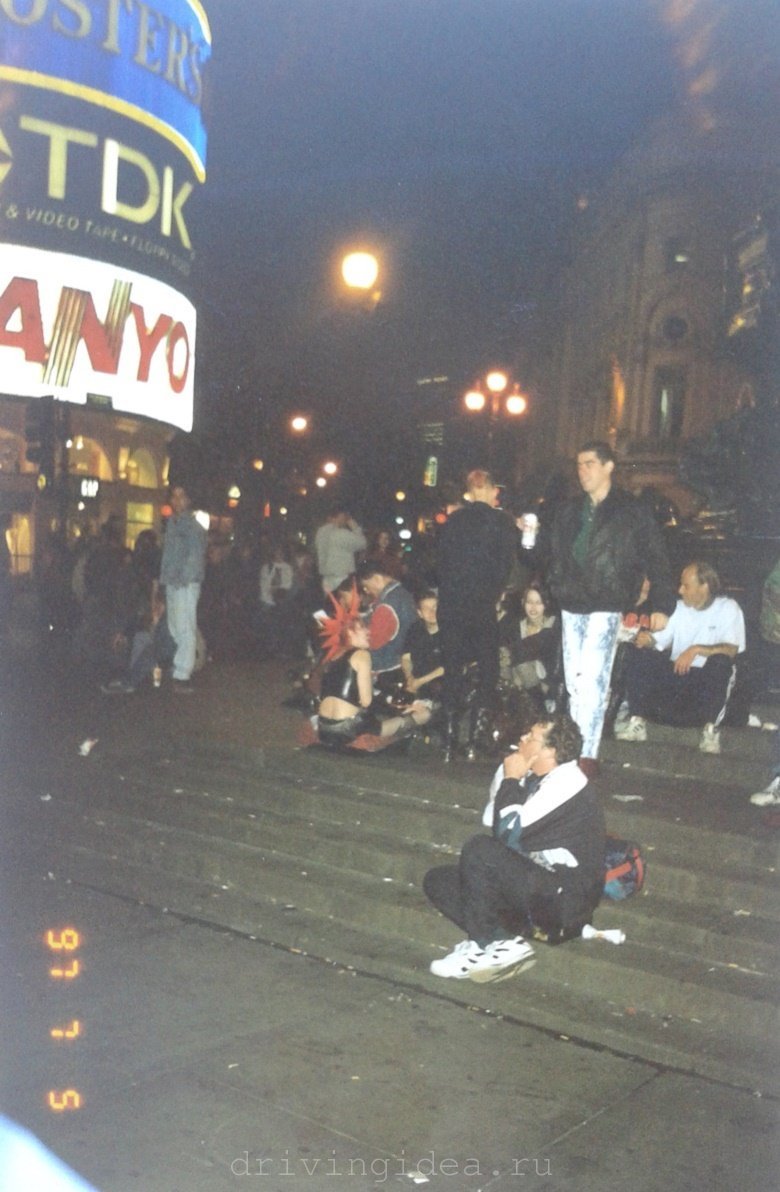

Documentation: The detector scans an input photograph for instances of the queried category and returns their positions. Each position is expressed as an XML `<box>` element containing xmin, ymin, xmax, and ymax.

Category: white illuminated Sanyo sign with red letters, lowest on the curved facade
<box><xmin>0</xmin><ymin>244</ymin><xmax>196</xmax><ymax>430</ymax></box>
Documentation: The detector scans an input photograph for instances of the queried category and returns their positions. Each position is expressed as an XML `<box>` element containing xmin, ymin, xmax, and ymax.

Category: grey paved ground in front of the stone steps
<box><xmin>0</xmin><ymin>658</ymin><xmax>780</xmax><ymax>1192</ymax></box>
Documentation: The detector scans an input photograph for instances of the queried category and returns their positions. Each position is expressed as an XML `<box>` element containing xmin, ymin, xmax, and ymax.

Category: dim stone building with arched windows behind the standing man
<box><xmin>547</xmin><ymin>117</ymin><xmax>780</xmax><ymax>514</ymax></box>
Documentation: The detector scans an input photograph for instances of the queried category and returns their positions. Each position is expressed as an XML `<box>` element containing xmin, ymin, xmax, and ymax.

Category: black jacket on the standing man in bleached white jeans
<box><xmin>547</xmin><ymin>485</ymin><xmax>676</xmax><ymax>615</ymax></box>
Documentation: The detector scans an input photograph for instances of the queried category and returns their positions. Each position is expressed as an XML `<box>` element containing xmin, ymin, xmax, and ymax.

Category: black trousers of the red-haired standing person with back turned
<box><xmin>439</xmin><ymin>607</ymin><xmax>499</xmax><ymax>713</ymax></box>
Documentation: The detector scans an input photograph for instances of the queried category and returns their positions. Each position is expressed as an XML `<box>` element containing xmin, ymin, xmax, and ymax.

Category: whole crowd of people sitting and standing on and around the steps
<box><xmin>15</xmin><ymin>441</ymin><xmax>780</xmax><ymax>981</ymax></box>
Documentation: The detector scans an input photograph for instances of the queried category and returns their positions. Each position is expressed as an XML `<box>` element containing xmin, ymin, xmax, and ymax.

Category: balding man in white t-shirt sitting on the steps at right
<box><xmin>615</xmin><ymin>563</ymin><xmax>745</xmax><ymax>753</ymax></box>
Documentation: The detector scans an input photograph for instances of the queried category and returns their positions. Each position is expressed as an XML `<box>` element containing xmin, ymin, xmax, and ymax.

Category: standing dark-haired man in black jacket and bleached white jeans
<box><xmin>547</xmin><ymin>440</ymin><xmax>676</xmax><ymax>777</ymax></box>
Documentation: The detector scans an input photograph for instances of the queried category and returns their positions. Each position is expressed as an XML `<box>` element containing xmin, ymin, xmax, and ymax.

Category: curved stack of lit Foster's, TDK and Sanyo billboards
<box><xmin>0</xmin><ymin>0</ymin><xmax>211</xmax><ymax>429</ymax></box>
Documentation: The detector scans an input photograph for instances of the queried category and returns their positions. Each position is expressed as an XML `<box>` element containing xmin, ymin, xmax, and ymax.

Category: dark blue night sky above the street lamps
<box><xmin>190</xmin><ymin>0</ymin><xmax>780</xmax><ymax>507</ymax></box>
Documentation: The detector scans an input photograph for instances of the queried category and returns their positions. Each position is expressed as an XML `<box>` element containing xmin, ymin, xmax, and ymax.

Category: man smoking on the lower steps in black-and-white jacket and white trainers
<box><xmin>423</xmin><ymin>715</ymin><xmax>605</xmax><ymax>981</ymax></box>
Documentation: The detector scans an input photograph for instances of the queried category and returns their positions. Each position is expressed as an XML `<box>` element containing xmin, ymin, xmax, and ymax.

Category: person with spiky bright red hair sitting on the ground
<box><xmin>317</xmin><ymin>589</ymin><xmax>431</xmax><ymax>749</ymax></box>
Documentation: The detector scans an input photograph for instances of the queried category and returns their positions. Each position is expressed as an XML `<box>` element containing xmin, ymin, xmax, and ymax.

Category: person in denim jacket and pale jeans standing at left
<box><xmin>160</xmin><ymin>484</ymin><xmax>208</xmax><ymax>694</ymax></box>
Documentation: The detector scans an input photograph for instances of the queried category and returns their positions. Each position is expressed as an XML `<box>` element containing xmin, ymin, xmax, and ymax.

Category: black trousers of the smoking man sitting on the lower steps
<box><xmin>422</xmin><ymin>834</ymin><xmax>563</xmax><ymax>946</ymax></box>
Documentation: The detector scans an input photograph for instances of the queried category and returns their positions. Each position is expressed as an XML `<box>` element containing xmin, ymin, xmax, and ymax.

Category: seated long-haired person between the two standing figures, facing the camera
<box><xmin>499</xmin><ymin>584</ymin><xmax>561</xmax><ymax>710</ymax></box>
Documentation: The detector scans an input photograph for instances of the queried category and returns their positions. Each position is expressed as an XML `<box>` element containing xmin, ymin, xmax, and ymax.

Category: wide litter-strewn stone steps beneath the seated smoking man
<box><xmin>6</xmin><ymin>719</ymin><xmax>780</xmax><ymax>1091</ymax></box>
